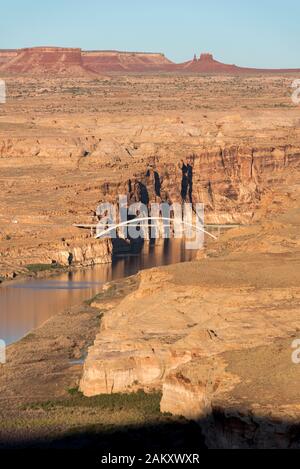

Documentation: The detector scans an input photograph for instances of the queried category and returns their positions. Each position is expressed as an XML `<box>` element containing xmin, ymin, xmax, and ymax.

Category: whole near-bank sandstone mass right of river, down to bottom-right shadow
<box><xmin>81</xmin><ymin>179</ymin><xmax>300</xmax><ymax>448</ymax></box>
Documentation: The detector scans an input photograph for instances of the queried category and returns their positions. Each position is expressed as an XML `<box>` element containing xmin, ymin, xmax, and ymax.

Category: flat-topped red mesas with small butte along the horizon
<box><xmin>0</xmin><ymin>47</ymin><xmax>300</xmax><ymax>77</ymax></box>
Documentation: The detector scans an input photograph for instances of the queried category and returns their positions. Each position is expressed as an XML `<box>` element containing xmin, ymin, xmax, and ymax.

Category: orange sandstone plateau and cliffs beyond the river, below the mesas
<box><xmin>0</xmin><ymin>76</ymin><xmax>300</xmax><ymax>276</ymax></box>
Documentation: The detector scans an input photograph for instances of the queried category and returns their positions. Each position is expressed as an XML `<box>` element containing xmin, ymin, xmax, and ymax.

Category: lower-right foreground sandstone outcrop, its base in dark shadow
<box><xmin>161</xmin><ymin>337</ymin><xmax>300</xmax><ymax>449</ymax></box>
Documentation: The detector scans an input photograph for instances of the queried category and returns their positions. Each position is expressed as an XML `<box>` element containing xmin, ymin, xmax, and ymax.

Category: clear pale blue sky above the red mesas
<box><xmin>0</xmin><ymin>0</ymin><xmax>300</xmax><ymax>67</ymax></box>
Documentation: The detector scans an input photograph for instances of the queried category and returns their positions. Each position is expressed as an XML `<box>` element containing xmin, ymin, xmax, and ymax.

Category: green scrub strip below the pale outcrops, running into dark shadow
<box><xmin>17</xmin><ymin>389</ymin><xmax>205</xmax><ymax>452</ymax></box>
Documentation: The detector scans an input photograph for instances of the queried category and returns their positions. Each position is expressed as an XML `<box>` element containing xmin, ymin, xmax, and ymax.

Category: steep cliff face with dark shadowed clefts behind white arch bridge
<box><xmin>96</xmin><ymin>145</ymin><xmax>300</xmax><ymax>224</ymax></box>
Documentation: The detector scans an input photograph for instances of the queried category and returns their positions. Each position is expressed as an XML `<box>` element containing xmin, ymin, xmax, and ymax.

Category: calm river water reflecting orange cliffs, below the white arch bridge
<box><xmin>0</xmin><ymin>240</ymin><xmax>196</xmax><ymax>344</ymax></box>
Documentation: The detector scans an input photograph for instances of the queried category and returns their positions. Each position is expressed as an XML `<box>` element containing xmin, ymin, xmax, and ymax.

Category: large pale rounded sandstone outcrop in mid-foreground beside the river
<box><xmin>81</xmin><ymin>254</ymin><xmax>300</xmax><ymax>396</ymax></box>
